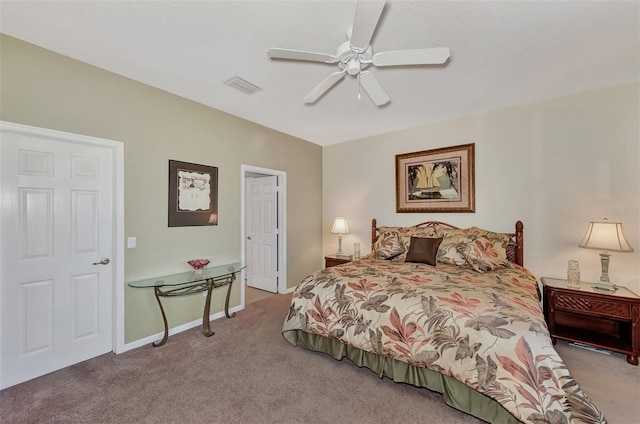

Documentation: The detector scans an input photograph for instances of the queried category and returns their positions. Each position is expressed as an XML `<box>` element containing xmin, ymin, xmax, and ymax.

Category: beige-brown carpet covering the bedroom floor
<box><xmin>0</xmin><ymin>295</ymin><xmax>640</xmax><ymax>424</ymax></box>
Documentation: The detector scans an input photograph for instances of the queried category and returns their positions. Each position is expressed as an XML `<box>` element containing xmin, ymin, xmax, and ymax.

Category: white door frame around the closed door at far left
<box><xmin>0</xmin><ymin>121</ymin><xmax>126</xmax><ymax>353</ymax></box>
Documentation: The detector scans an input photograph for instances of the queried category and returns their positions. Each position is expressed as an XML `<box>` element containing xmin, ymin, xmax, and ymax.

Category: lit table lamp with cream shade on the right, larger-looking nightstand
<box><xmin>578</xmin><ymin>218</ymin><xmax>633</xmax><ymax>292</ymax></box>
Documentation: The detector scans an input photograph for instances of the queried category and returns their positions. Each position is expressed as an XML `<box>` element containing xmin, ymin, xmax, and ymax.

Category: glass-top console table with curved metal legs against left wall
<box><xmin>129</xmin><ymin>262</ymin><xmax>245</xmax><ymax>347</ymax></box>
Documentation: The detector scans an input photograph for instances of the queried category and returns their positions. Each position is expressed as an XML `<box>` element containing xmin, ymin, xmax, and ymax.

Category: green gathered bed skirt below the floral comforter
<box><xmin>284</xmin><ymin>330</ymin><xmax>520</xmax><ymax>424</ymax></box>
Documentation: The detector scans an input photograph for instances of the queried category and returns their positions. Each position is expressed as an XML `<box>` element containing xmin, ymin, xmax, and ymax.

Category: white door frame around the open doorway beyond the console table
<box><xmin>240</xmin><ymin>164</ymin><xmax>287</xmax><ymax>308</ymax></box>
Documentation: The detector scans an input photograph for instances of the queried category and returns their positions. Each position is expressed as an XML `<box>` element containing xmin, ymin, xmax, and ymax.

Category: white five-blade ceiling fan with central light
<box><xmin>267</xmin><ymin>0</ymin><xmax>450</xmax><ymax>106</ymax></box>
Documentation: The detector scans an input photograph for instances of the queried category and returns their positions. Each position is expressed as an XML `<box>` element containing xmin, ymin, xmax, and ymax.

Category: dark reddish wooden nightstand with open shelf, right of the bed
<box><xmin>541</xmin><ymin>277</ymin><xmax>640</xmax><ymax>365</ymax></box>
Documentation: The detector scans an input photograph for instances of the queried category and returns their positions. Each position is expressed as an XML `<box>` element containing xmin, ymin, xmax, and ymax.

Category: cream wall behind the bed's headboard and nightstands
<box><xmin>323</xmin><ymin>82</ymin><xmax>640</xmax><ymax>294</ymax></box>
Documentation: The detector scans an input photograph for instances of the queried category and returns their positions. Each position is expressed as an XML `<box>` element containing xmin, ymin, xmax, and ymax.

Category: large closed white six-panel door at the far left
<box><xmin>0</xmin><ymin>130</ymin><xmax>115</xmax><ymax>388</ymax></box>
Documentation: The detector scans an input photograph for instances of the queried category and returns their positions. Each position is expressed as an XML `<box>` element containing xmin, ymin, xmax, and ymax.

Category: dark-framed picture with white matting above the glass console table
<box><xmin>169</xmin><ymin>160</ymin><xmax>218</xmax><ymax>227</ymax></box>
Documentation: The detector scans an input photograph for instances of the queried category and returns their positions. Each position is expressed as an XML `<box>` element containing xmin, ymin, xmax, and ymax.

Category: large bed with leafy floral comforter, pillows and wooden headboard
<box><xmin>282</xmin><ymin>219</ymin><xmax>606</xmax><ymax>424</ymax></box>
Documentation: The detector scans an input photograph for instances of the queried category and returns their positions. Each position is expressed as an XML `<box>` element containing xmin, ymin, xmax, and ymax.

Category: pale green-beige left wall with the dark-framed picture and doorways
<box><xmin>0</xmin><ymin>35</ymin><xmax>322</xmax><ymax>342</ymax></box>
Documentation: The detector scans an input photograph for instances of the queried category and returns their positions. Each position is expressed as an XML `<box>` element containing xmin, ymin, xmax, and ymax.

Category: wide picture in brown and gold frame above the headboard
<box><xmin>396</xmin><ymin>144</ymin><xmax>475</xmax><ymax>212</ymax></box>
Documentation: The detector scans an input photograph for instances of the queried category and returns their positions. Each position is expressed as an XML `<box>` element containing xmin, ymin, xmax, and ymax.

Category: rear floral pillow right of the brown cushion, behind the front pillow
<box><xmin>437</xmin><ymin>227</ymin><xmax>510</xmax><ymax>265</ymax></box>
